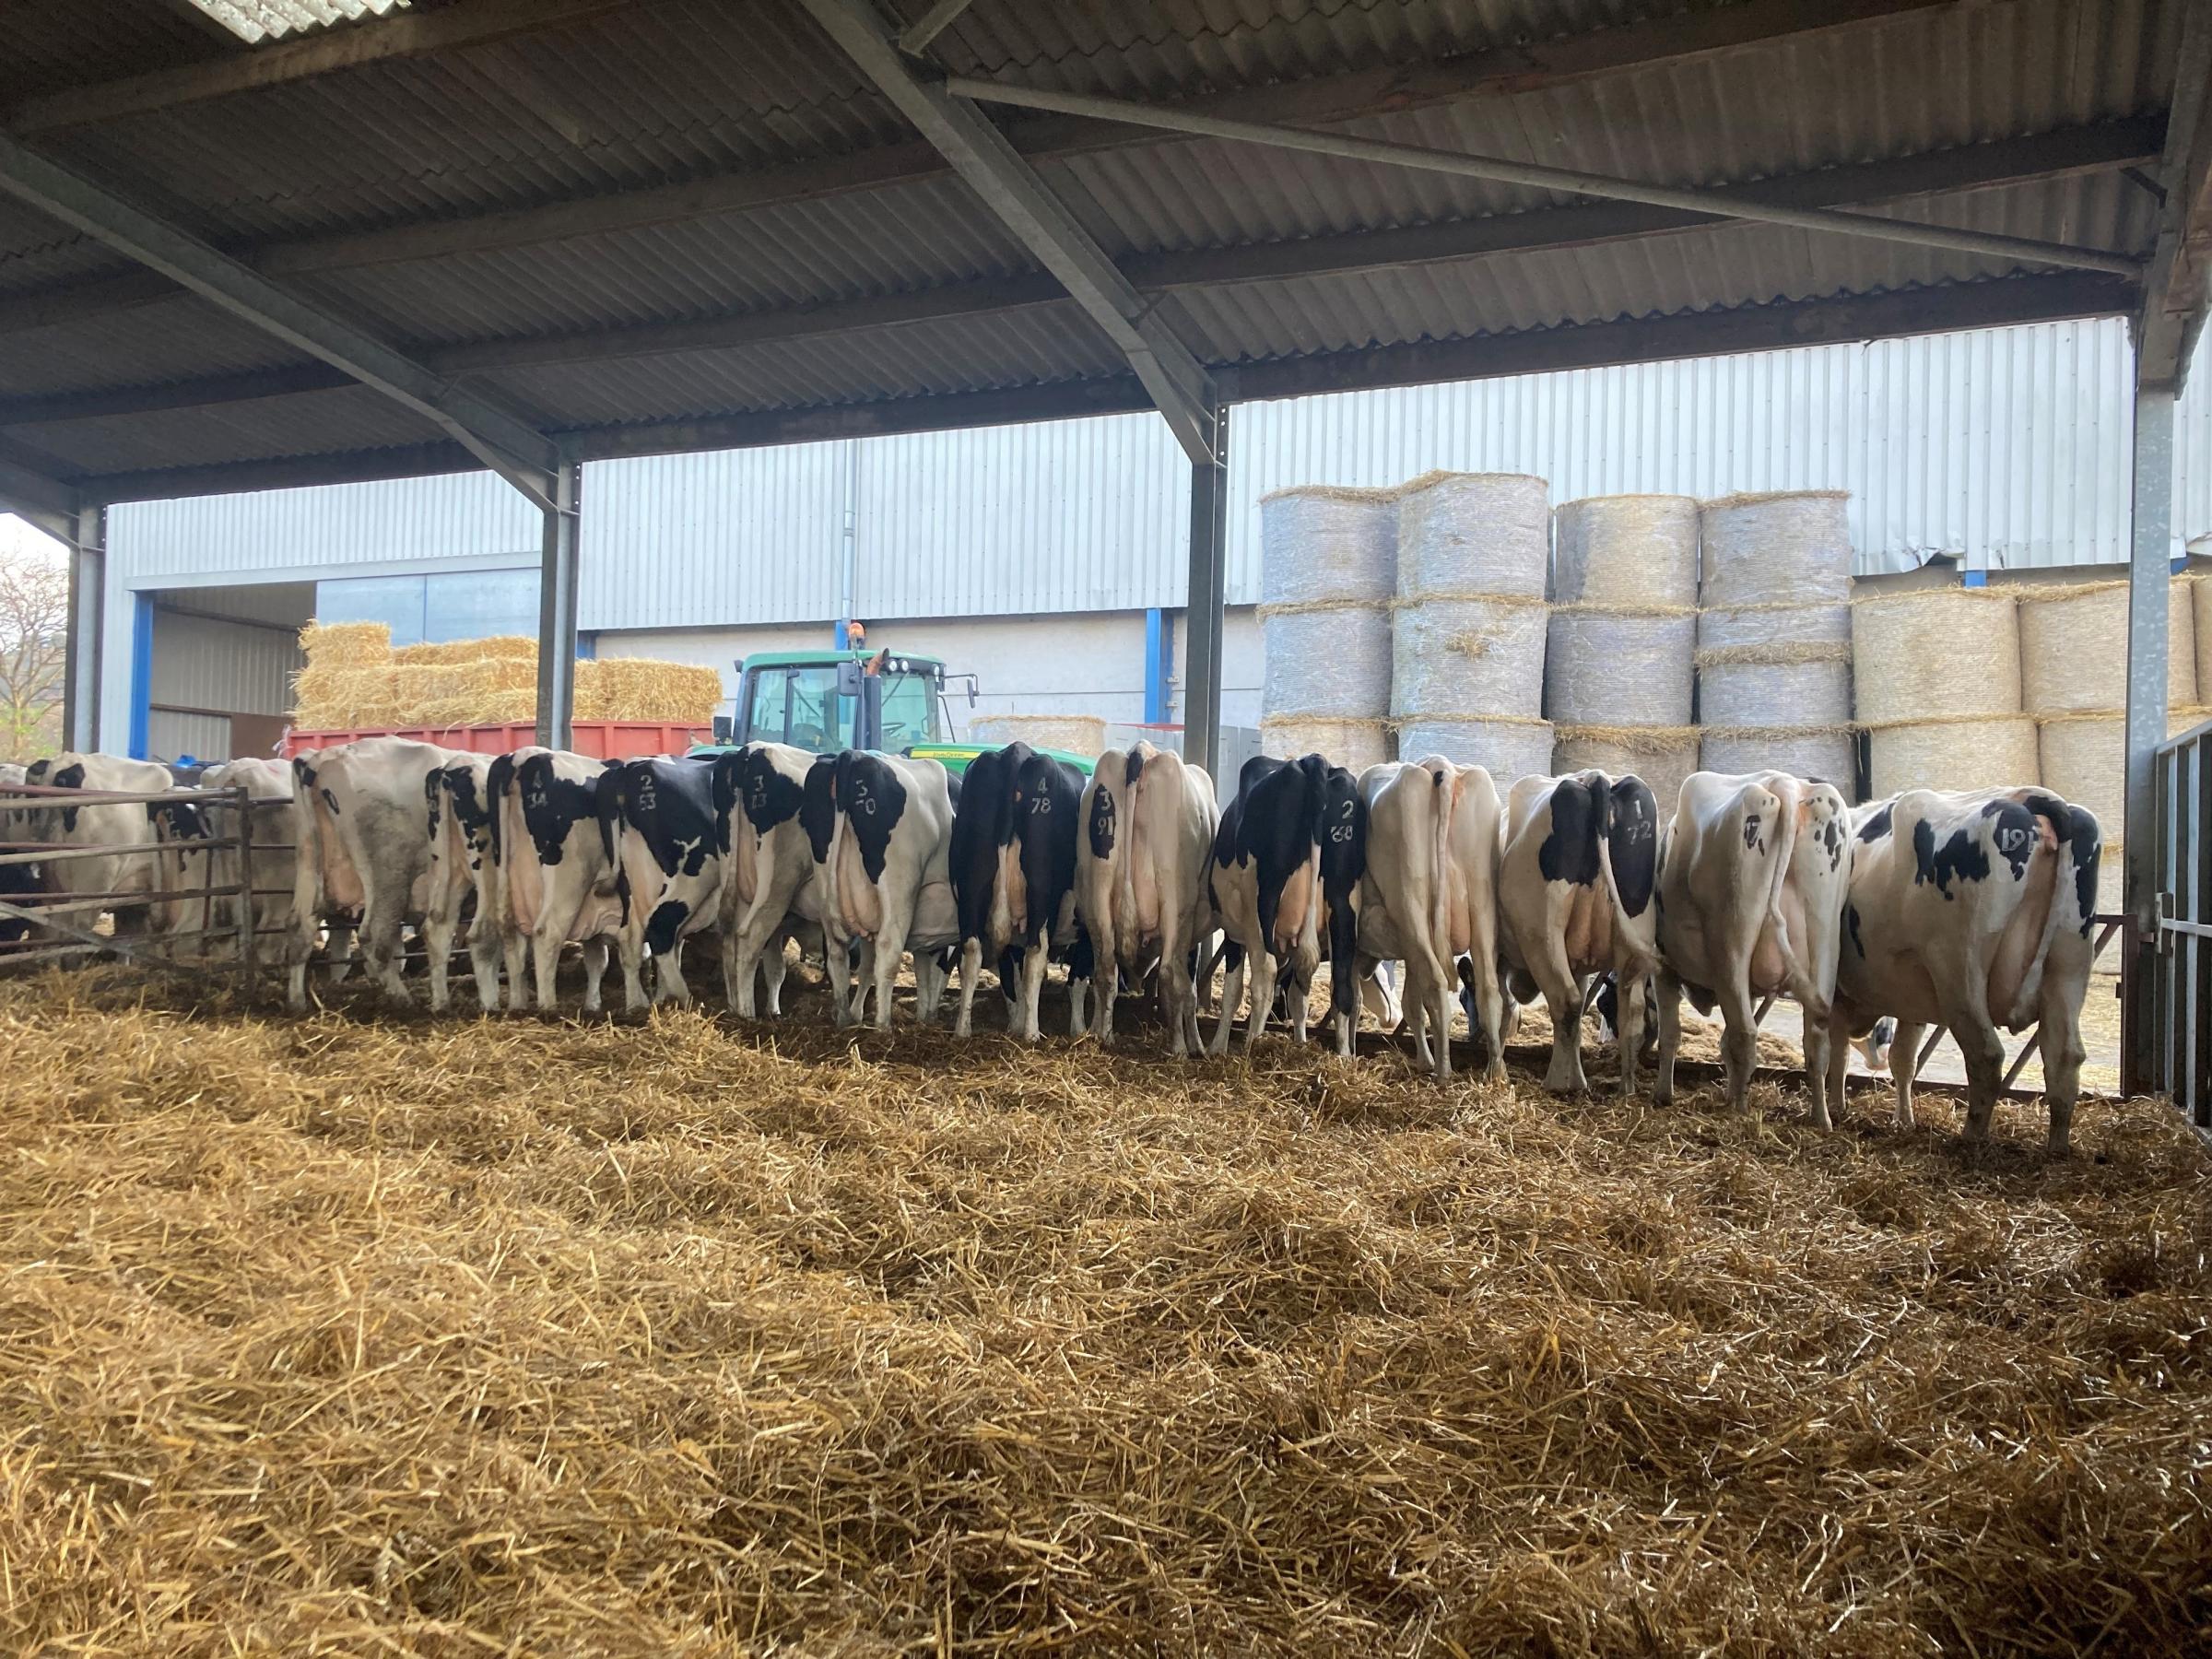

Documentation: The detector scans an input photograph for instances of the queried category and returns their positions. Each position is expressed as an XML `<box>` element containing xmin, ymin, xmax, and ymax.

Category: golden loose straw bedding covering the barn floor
<box><xmin>0</xmin><ymin>971</ymin><xmax>2212</xmax><ymax>1654</ymax></box>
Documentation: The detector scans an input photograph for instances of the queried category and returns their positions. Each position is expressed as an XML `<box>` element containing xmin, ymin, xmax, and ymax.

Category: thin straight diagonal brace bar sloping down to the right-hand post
<box><xmin>945</xmin><ymin>76</ymin><xmax>2144</xmax><ymax>276</ymax></box>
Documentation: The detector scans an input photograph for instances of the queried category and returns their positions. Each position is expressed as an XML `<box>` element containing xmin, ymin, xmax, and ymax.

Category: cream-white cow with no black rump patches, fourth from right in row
<box><xmin>1360</xmin><ymin>754</ymin><xmax>1506</xmax><ymax>1082</ymax></box>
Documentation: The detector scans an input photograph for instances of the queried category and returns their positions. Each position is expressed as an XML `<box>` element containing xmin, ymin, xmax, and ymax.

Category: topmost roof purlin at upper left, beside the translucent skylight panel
<box><xmin>13</xmin><ymin>0</ymin><xmax>637</xmax><ymax>135</ymax></box>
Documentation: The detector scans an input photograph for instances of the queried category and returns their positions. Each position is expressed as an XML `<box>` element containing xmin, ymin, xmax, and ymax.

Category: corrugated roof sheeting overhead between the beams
<box><xmin>0</xmin><ymin>0</ymin><xmax>2185</xmax><ymax>493</ymax></box>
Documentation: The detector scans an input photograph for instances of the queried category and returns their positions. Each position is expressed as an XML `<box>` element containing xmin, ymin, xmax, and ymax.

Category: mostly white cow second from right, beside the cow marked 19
<box><xmin>1654</xmin><ymin>772</ymin><xmax>1852</xmax><ymax>1128</ymax></box>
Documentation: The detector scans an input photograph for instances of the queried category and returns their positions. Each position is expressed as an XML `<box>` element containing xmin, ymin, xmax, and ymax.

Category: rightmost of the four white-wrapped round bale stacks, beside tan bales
<box><xmin>1697</xmin><ymin>488</ymin><xmax>1858</xmax><ymax>796</ymax></box>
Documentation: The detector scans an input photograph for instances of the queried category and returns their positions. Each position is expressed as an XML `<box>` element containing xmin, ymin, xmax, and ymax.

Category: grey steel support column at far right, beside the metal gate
<box><xmin>2106</xmin><ymin>385</ymin><xmax>2174</xmax><ymax>1095</ymax></box>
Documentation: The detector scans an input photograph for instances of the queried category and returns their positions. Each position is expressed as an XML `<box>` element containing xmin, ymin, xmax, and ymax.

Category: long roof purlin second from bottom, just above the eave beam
<box><xmin>0</xmin><ymin>117</ymin><xmax>2163</xmax><ymax>427</ymax></box>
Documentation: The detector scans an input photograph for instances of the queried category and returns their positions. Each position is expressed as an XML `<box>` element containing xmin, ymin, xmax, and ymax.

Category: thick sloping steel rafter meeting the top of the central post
<box><xmin>801</xmin><ymin>0</ymin><xmax>1221</xmax><ymax>460</ymax></box>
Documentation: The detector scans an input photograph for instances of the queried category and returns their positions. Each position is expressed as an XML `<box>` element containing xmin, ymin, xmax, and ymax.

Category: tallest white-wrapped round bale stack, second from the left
<box><xmin>1392</xmin><ymin>474</ymin><xmax>1550</xmax><ymax>790</ymax></box>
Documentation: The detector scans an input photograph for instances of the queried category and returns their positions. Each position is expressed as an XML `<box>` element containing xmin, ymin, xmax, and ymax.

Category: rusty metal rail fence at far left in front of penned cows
<box><xmin>0</xmin><ymin>783</ymin><xmax>292</xmax><ymax>997</ymax></box>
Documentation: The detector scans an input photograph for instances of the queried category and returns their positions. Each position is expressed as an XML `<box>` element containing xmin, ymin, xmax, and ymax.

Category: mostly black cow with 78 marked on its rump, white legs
<box><xmin>949</xmin><ymin>743</ymin><xmax>1090</xmax><ymax>1041</ymax></box>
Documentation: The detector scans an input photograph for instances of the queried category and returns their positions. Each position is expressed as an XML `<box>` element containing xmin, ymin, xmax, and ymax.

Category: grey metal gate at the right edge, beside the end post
<box><xmin>2136</xmin><ymin>721</ymin><xmax>2212</xmax><ymax>1128</ymax></box>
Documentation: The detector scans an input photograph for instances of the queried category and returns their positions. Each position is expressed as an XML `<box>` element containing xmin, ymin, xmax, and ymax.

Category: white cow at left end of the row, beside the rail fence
<box><xmin>288</xmin><ymin>736</ymin><xmax>465</xmax><ymax>1008</ymax></box>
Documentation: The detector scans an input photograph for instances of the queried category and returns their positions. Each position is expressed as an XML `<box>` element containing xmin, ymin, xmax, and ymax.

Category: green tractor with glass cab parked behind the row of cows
<box><xmin>692</xmin><ymin>648</ymin><xmax>1095</xmax><ymax>776</ymax></box>
